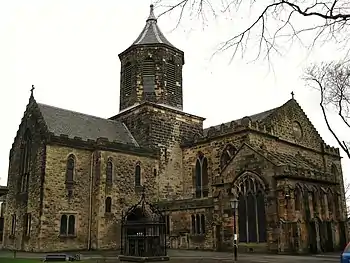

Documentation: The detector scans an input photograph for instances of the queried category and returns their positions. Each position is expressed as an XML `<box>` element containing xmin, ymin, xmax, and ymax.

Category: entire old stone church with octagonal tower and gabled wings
<box><xmin>3</xmin><ymin>6</ymin><xmax>347</xmax><ymax>253</ymax></box>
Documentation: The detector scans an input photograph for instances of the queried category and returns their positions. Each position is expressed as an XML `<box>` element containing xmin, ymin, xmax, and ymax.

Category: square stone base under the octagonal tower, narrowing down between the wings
<box><xmin>114</xmin><ymin>104</ymin><xmax>203</xmax><ymax>199</ymax></box>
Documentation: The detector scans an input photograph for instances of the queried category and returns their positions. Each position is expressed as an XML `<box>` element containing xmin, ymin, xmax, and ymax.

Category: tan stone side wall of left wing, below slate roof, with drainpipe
<box><xmin>40</xmin><ymin>146</ymin><xmax>157</xmax><ymax>251</ymax></box>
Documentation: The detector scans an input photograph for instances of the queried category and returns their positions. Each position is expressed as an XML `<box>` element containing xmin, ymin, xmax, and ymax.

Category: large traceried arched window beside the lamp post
<box><xmin>235</xmin><ymin>173</ymin><xmax>267</xmax><ymax>243</ymax></box>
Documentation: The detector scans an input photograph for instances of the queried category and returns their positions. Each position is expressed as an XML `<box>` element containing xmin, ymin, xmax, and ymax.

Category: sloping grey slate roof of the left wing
<box><xmin>38</xmin><ymin>103</ymin><xmax>139</xmax><ymax>146</ymax></box>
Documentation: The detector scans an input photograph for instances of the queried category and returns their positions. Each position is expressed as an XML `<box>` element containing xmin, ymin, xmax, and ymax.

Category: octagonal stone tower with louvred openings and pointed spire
<box><xmin>119</xmin><ymin>5</ymin><xmax>184</xmax><ymax>111</ymax></box>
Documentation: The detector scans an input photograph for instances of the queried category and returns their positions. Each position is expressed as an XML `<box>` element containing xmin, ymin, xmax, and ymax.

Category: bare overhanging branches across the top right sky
<box><xmin>156</xmin><ymin>0</ymin><xmax>350</xmax><ymax>59</ymax></box>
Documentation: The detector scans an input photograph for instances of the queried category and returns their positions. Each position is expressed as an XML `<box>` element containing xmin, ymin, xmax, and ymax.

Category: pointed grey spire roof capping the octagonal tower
<box><xmin>133</xmin><ymin>5</ymin><xmax>174</xmax><ymax>47</ymax></box>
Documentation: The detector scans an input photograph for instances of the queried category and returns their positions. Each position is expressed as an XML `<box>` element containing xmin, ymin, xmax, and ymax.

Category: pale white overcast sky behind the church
<box><xmin>0</xmin><ymin>0</ymin><xmax>350</xmax><ymax>188</ymax></box>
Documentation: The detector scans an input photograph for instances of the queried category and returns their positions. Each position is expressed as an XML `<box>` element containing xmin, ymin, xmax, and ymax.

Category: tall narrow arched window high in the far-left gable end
<box><xmin>20</xmin><ymin>129</ymin><xmax>32</xmax><ymax>192</ymax></box>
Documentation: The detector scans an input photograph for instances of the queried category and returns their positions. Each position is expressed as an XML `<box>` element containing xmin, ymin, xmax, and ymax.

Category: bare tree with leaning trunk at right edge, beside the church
<box><xmin>304</xmin><ymin>61</ymin><xmax>350</xmax><ymax>158</ymax></box>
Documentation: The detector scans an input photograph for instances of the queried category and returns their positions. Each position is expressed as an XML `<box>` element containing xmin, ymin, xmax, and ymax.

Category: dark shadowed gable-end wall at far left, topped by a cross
<box><xmin>3</xmin><ymin>100</ymin><xmax>46</xmax><ymax>251</ymax></box>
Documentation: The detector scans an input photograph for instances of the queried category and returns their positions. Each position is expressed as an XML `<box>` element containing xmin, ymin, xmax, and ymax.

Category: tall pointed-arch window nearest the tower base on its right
<box><xmin>195</xmin><ymin>154</ymin><xmax>209</xmax><ymax>198</ymax></box>
